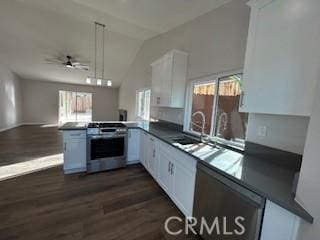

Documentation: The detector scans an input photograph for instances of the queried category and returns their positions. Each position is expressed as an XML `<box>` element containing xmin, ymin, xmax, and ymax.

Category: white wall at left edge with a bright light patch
<box><xmin>0</xmin><ymin>65</ymin><xmax>22</xmax><ymax>131</ymax></box>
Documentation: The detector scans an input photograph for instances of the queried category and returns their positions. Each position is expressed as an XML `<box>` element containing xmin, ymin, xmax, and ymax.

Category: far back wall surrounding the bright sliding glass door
<box><xmin>21</xmin><ymin>80</ymin><xmax>119</xmax><ymax>124</ymax></box>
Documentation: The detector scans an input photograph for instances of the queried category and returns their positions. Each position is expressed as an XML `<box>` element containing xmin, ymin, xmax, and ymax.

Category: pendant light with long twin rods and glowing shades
<box><xmin>86</xmin><ymin>22</ymin><xmax>112</xmax><ymax>87</ymax></box>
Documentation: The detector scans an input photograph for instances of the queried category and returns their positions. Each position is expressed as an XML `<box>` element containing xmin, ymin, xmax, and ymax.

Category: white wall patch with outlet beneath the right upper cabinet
<box><xmin>247</xmin><ymin>113</ymin><xmax>309</xmax><ymax>154</ymax></box>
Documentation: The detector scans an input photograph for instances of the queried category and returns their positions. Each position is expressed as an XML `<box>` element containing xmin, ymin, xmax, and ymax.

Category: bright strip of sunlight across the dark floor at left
<box><xmin>0</xmin><ymin>154</ymin><xmax>63</xmax><ymax>181</ymax></box>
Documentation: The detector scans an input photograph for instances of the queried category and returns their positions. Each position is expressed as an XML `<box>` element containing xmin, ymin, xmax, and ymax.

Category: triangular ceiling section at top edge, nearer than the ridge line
<box><xmin>73</xmin><ymin>0</ymin><xmax>230</xmax><ymax>33</ymax></box>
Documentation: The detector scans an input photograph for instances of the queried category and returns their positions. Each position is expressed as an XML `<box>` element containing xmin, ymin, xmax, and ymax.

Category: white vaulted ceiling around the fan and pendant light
<box><xmin>0</xmin><ymin>0</ymin><xmax>230</xmax><ymax>87</ymax></box>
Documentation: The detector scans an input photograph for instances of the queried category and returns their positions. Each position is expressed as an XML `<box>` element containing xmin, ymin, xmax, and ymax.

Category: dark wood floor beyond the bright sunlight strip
<box><xmin>0</xmin><ymin>125</ymin><xmax>62</xmax><ymax>167</ymax></box>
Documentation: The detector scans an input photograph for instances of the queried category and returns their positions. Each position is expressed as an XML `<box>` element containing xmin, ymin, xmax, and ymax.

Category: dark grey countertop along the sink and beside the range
<box><xmin>60</xmin><ymin>122</ymin><xmax>313</xmax><ymax>223</ymax></box>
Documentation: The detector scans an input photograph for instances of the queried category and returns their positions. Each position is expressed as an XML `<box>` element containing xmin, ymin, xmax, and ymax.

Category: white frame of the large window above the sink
<box><xmin>183</xmin><ymin>69</ymin><xmax>243</xmax><ymax>149</ymax></box>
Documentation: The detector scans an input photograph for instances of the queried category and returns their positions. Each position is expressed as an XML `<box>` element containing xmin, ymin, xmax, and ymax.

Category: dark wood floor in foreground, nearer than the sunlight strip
<box><xmin>0</xmin><ymin>165</ymin><xmax>197</xmax><ymax>240</ymax></box>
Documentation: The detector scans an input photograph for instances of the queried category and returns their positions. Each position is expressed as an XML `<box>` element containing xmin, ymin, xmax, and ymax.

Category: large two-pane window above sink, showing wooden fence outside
<box><xmin>184</xmin><ymin>71</ymin><xmax>248</xmax><ymax>149</ymax></box>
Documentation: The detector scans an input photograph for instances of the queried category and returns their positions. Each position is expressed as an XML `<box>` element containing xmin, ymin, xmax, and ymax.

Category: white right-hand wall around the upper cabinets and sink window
<box><xmin>119</xmin><ymin>0</ymin><xmax>309</xmax><ymax>154</ymax></box>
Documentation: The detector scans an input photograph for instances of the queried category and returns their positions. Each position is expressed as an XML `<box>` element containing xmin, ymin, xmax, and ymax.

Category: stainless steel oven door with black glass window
<box><xmin>87</xmin><ymin>135</ymin><xmax>127</xmax><ymax>172</ymax></box>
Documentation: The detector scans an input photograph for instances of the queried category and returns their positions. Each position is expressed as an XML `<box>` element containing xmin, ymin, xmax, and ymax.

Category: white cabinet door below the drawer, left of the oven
<box><xmin>63</xmin><ymin>139</ymin><xmax>87</xmax><ymax>173</ymax></box>
